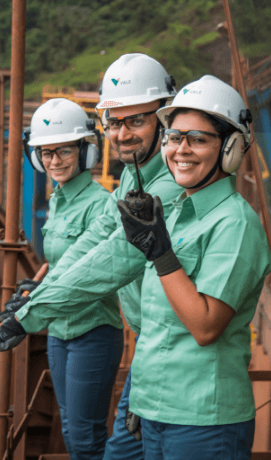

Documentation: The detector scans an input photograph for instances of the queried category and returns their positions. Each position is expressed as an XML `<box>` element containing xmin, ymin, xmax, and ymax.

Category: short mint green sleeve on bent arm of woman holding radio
<box><xmin>195</xmin><ymin>219</ymin><xmax>271</xmax><ymax>311</ymax></box>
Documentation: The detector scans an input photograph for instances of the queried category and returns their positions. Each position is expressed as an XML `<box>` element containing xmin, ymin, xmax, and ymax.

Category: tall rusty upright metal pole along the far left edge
<box><xmin>0</xmin><ymin>0</ymin><xmax>26</xmax><ymax>458</ymax></box>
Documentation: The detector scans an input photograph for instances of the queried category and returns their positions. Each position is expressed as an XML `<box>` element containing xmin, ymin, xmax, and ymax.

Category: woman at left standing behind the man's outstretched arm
<box><xmin>0</xmin><ymin>98</ymin><xmax>123</xmax><ymax>460</ymax></box>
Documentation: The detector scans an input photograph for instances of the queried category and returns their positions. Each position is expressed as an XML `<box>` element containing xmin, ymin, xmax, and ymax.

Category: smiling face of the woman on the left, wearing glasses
<box><xmin>41</xmin><ymin>142</ymin><xmax>80</xmax><ymax>187</ymax></box>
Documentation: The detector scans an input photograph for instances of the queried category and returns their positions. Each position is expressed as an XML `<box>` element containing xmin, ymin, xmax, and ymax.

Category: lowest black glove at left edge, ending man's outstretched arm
<box><xmin>0</xmin><ymin>315</ymin><xmax>27</xmax><ymax>351</ymax></box>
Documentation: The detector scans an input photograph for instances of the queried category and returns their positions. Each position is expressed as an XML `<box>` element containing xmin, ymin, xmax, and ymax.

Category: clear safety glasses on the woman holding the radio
<box><xmin>161</xmin><ymin>129</ymin><xmax>220</xmax><ymax>150</ymax></box>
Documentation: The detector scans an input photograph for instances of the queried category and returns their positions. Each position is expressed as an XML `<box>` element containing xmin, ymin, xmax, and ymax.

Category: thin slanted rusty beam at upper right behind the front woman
<box><xmin>223</xmin><ymin>0</ymin><xmax>271</xmax><ymax>248</ymax></box>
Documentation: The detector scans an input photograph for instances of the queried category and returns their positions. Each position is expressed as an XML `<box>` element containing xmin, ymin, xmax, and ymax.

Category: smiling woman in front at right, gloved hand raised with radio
<box><xmin>118</xmin><ymin>75</ymin><xmax>271</xmax><ymax>460</ymax></box>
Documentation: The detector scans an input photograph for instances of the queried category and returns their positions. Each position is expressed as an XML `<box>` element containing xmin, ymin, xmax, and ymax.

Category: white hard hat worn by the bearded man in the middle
<box><xmin>96</xmin><ymin>53</ymin><xmax>176</xmax><ymax>109</ymax></box>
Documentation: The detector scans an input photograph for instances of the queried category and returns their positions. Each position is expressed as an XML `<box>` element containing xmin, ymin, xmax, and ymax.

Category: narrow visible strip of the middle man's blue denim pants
<box><xmin>103</xmin><ymin>369</ymin><xmax>144</xmax><ymax>460</ymax></box>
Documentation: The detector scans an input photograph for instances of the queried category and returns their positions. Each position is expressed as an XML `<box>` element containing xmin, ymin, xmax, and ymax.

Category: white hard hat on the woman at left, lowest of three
<box><xmin>28</xmin><ymin>98</ymin><xmax>94</xmax><ymax>146</ymax></box>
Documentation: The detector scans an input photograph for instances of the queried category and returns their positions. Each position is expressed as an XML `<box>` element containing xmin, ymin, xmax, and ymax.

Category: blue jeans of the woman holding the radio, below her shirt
<box><xmin>141</xmin><ymin>418</ymin><xmax>255</xmax><ymax>460</ymax></box>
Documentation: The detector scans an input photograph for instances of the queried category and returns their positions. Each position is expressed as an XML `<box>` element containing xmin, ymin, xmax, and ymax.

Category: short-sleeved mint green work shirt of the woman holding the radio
<box><xmin>129</xmin><ymin>176</ymin><xmax>271</xmax><ymax>425</ymax></box>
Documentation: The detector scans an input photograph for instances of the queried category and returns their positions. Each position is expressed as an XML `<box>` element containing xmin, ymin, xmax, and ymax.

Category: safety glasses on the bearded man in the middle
<box><xmin>105</xmin><ymin>110</ymin><xmax>156</xmax><ymax>132</ymax></box>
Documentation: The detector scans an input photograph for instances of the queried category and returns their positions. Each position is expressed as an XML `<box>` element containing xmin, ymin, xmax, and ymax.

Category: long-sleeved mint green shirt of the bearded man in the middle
<box><xmin>18</xmin><ymin>153</ymin><xmax>183</xmax><ymax>333</ymax></box>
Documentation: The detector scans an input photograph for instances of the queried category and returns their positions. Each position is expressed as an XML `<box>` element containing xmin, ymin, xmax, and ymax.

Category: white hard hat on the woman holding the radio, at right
<box><xmin>156</xmin><ymin>75</ymin><xmax>251</xmax><ymax>134</ymax></box>
